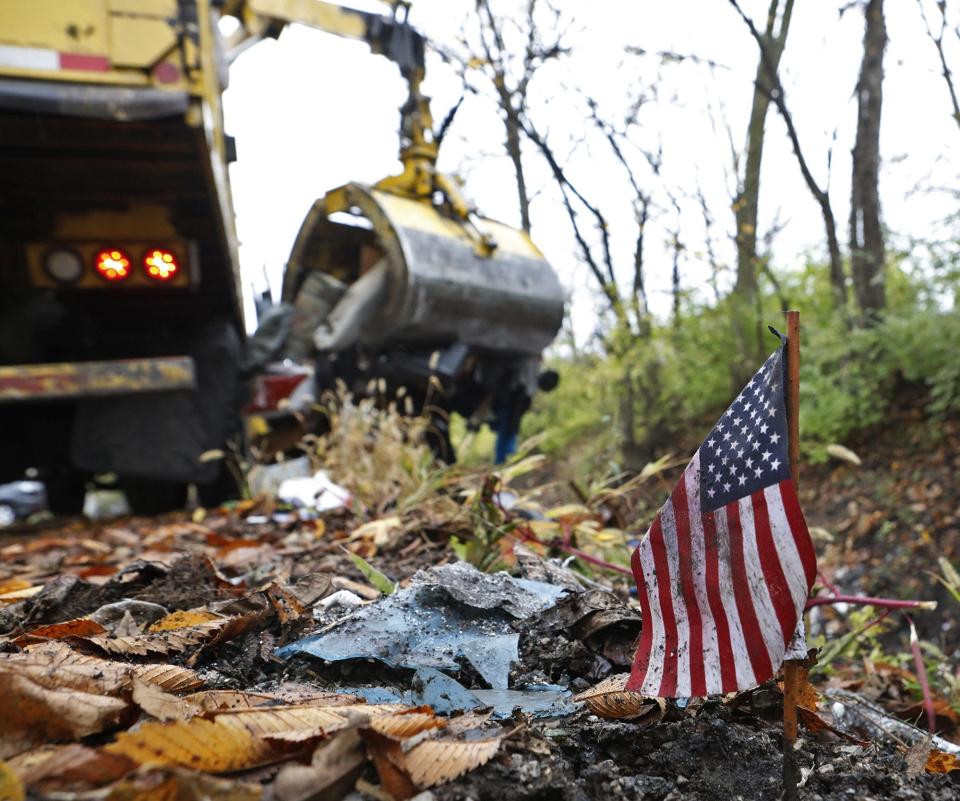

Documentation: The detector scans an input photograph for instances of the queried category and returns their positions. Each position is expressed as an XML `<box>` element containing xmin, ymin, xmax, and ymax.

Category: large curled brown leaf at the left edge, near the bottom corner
<box><xmin>0</xmin><ymin>671</ymin><xmax>129</xmax><ymax>758</ymax></box>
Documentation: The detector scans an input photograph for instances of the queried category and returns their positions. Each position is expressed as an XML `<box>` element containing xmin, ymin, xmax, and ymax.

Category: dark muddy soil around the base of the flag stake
<box><xmin>433</xmin><ymin>705</ymin><xmax>960</xmax><ymax>801</ymax></box>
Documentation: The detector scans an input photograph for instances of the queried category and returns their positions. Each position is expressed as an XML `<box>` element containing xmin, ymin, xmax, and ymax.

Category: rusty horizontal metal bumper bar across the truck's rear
<box><xmin>0</xmin><ymin>356</ymin><xmax>196</xmax><ymax>403</ymax></box>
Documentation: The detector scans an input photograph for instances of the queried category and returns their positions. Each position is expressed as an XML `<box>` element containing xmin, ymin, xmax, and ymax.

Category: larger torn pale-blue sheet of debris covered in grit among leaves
<box><xmin>277</xmin><ymin>562</ymin><xmax>565</xmax><ymax>689</ymax></box>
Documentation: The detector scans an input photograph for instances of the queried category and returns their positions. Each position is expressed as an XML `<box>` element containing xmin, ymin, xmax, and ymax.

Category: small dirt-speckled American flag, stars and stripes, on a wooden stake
<box><xmin>627</xmin><ymin>334</ymin><xmax>816</xmax><ymax>698</ymax></box>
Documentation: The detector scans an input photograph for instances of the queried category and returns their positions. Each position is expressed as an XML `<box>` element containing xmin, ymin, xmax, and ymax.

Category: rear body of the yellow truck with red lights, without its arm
<box><xmin>0</xmin><ymin>0</ymin><xmax>244</xmax><ymax>511</ymax></box>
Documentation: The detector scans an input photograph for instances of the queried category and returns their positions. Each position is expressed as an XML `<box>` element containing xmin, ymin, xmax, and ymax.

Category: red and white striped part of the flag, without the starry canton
<box><xmin>627</xmin><ymin>451</ymin><xmax>816</xmax><ymax>698</ymax></box>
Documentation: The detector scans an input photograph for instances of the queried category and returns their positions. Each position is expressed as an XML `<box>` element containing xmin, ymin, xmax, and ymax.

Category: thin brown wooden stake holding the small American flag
<box><xmin>783</xmin><ymin>311</ymin><xmax>802</xmax><ymax>801</ymax></box>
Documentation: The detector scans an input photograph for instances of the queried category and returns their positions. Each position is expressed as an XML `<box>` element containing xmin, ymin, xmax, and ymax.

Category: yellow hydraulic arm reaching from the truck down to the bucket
<box><xmin>224</xmin><ymin>0</ymin><xmax>496</xmax><ymax>254</ymax></box>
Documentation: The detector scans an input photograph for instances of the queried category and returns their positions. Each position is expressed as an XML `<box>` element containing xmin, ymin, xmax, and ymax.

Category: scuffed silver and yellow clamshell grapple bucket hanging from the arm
<box><xmin>283</xmin><ymin>184</ymin><xmax>563</xmax><ymax>355</ymax></box>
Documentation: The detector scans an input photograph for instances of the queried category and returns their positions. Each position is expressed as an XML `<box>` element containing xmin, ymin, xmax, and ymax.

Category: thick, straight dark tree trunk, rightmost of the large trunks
<box><xmin>850</xmin><ymin>0</ymin><xmax>887</xmax><ymax>323</ymax></box>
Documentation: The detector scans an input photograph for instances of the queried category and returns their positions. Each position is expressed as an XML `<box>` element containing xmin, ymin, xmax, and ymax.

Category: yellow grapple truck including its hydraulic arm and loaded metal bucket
<box><xmin>0</xmin><ymin>0</ymin><xmax>563</xmax><ymax>512</ymax></box>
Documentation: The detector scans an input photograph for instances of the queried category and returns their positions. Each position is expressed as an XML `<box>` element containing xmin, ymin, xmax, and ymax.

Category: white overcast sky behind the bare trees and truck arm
<box><xmin>225</xmin><ymin>0</ymin><xmax>960</xmax><ymax>339</ymax></box>
